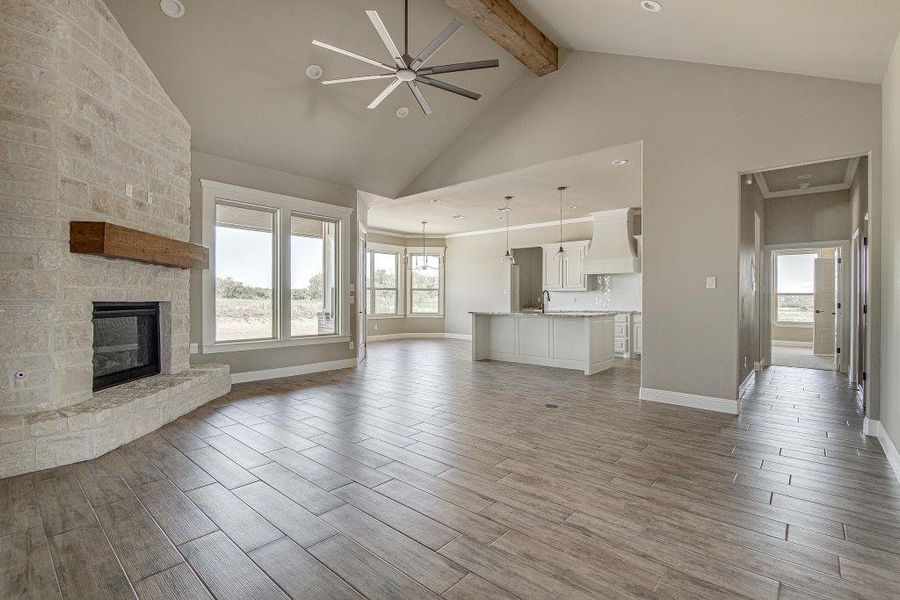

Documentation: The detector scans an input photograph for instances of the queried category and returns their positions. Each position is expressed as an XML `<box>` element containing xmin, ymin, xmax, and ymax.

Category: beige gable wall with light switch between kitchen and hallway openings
<box><xmin>407</xmin><ymin>52</ymin><xmax>881</xmax><ymax>406</ymax></box>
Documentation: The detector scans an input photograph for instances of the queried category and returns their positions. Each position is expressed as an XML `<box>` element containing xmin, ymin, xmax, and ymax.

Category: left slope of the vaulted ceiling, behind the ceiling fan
<box><xmin>106</xmin><ymin>0</ymin><xmax>525</xmax><ymax>196</ymax></box>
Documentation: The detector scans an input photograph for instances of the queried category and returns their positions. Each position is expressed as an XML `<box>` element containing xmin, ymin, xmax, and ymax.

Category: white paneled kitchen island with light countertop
<box><xmin>470</xmin><ymin>312</ymin><xmax>616</xmax><ymax>375</ymax></box>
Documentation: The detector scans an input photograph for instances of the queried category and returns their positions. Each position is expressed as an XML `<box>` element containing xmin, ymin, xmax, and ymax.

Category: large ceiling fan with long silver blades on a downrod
<box><xmin>313</xmin><ymin>0</ymin><xmax>500</xmax><ymax>115</ymax></box>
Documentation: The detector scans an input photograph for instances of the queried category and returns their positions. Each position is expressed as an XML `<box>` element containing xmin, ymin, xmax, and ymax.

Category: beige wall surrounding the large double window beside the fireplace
<box><xmin>191</xmin><ymin>152</ymin><xmax>358</xmax><ymax>373</ymax></box>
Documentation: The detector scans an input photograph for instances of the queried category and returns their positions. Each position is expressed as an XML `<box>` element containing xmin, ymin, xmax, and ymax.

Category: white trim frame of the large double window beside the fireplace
<box><xmin>200</xmin><ymin>179</ymin><xmax>355</xmax><ymax>354</ymax></box>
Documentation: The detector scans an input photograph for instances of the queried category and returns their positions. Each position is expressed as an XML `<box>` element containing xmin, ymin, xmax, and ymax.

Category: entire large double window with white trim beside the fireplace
<box><xmin>202</xmin><ymin>180</ymin><xmax>353</xmax><ymax>352</ymax></box>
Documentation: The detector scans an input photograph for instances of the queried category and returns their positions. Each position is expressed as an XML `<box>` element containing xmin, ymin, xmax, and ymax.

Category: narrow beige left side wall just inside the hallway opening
<box><xmin>738</xmin><ymin>178</ymin><xmax>767</xmax><ymax>383</ymax></box>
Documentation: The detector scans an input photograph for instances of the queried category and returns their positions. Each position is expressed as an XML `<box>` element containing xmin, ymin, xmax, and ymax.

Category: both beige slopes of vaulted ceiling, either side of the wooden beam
<box><xmin>106</xmin><ymin>0</ymin><xmax>900</xmax><ymax>206</ymax></box>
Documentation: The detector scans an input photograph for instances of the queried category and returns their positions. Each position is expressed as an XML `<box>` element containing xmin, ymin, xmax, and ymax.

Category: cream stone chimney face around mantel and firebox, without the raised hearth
<box><xmin>0</xmin><ymin>0</ymin><xmax>191</xmax><ymax>412</ymax></box>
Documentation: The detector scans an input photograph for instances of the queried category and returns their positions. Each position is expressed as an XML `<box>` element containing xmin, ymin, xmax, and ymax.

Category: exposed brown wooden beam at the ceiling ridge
<box><xmin>444</xmin><ymin>0</ymin><xmax>559</xmax><ymax>77</ymax></box>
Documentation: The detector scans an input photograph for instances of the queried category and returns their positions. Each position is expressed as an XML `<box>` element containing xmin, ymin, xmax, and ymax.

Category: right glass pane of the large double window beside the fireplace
<box><xmin>291</xmin><ymin>215</ymin><xmax>337</xmax><ymax>337</ymax></box>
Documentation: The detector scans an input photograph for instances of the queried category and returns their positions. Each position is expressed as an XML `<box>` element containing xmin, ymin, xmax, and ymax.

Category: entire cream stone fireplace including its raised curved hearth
<box><xmin>0</xmin><ymin>0</ymin><xmax>230</xmax><ymax>477</ymax></box>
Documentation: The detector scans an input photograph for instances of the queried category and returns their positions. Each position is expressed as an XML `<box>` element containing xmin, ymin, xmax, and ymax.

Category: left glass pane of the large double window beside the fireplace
<box><xmin>214</xmin><ymin>202</ymin><xmax>277</xmax><ymax>342</ymax></box>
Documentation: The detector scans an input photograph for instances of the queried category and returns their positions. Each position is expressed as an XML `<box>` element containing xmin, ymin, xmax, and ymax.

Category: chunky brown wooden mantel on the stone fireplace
<box><xmin>69</xmin><ymin>221</ymin><xmax>209</xmax><ymax>269</ymax></box>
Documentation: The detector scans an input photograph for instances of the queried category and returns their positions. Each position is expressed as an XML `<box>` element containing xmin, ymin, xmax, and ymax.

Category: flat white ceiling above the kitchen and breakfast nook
<box><xmin>367</xmin><ymin>142</ymin><xmax>642</xmax><ymax>234</ymax></box>
